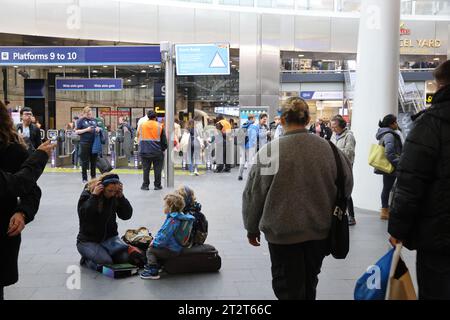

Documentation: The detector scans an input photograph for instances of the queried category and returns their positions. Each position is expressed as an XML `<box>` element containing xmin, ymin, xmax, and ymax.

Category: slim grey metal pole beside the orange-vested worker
<box><xmin>160</xmin><ymin>41</ymin><xmax>175</xmax><ymax>188</ymax></box>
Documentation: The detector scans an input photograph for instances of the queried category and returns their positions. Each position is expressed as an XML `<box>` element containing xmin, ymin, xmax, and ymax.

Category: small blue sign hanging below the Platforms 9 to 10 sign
<box><xmin>56</xmin><ymin>78</ymin><xmax>123</xmax><ymax>91</ymax></box>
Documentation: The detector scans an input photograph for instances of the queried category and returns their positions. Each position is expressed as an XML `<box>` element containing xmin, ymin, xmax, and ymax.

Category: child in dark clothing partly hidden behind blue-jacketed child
<box><xmin>175</xmin><ymin>186</ymin><xmax>208</xmax><ymax>247</ymax></box>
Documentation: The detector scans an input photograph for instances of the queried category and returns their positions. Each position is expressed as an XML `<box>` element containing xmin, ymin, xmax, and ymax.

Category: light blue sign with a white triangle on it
<box><xmin>175</xmin><ymin>44</ymin><xmax>230</xmax><ymax>76</ymax></box>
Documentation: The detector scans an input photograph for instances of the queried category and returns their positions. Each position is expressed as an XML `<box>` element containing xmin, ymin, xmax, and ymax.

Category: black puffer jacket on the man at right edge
<box><xmin>388</xmin><ymin>86</ymin><xmax>450</xmax><ymax>256</ymax></box>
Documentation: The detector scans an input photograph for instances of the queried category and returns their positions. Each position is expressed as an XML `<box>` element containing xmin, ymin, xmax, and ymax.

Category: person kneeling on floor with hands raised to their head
<box><xmin>77</xmin><ymin>173</ymin><xmax>133</xmax><ymax>270</ymax></box>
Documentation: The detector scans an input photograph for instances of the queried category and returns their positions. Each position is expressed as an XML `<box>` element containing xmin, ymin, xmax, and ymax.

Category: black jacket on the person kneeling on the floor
<box><xmin>77</xmin><ymin>190</ymin><xmax>133</xmax><ymax>243</ymax></box>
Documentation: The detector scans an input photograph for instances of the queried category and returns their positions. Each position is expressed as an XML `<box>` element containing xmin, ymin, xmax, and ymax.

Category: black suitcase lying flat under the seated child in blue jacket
<box><xmin>163</xmin><ymin>244</ymin><xmax>222</xmax><ymax>274</ymax></box>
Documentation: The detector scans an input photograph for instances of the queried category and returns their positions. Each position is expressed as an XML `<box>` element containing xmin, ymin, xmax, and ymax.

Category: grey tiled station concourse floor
<box><xmin>5</xmin><ymin>170</ymin><xmax>415</xmax><ymax>299</ymax></box>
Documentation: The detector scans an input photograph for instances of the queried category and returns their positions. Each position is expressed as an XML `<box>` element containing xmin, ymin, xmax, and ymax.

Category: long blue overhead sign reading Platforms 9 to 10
<box><xmin>0</xmin><ymin>46</ymin><xmax>161</xmax><ymax>66</ymax></box>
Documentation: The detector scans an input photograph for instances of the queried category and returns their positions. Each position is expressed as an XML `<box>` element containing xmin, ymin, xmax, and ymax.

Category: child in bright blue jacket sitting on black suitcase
<box><xmin>141</xmin><ymin>194</ymin><xmax>195</xmax><ymax>280</ymax></box>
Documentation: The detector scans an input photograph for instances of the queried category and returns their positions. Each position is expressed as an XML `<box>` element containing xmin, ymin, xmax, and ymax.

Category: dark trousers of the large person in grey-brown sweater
<box><xmin>269</xmin><ymin>240</ymin><xmax>328</xmax><ymax>300</ymax></box>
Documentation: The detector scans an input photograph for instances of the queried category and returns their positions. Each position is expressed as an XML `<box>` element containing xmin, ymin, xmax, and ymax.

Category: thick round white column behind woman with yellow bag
<box><xmin>352</xmin><ymin>0</ymin><xmax>400</xmax><ymax>211</ymax></box>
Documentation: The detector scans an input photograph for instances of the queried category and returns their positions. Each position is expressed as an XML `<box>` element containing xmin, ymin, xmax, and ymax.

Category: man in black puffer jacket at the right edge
<box><xmin>388</xmin><ymin>60</ymin><xmax>450</xmax><ymax>300</ymax></box>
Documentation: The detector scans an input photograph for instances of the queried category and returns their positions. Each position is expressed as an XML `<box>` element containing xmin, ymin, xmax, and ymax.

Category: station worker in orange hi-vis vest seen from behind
<box><xmin>137</xmin><ymin>111</ymin><xmax>167</xmax><ymax>190</ymax></box>
